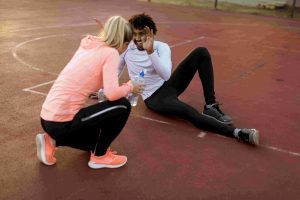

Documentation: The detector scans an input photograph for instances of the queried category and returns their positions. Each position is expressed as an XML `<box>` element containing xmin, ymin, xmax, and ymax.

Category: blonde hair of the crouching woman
<box><xmin>99</xmin><ymin>16</ymin><xmax>133</xmax><ymax>49</ymax></box>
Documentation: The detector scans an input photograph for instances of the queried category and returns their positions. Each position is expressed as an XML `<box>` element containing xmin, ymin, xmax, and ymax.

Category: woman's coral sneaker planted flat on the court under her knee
<box><xmin>88</xmin><ymin>148</ymin><xmax>127</xmax><ymax>169</ymax></box>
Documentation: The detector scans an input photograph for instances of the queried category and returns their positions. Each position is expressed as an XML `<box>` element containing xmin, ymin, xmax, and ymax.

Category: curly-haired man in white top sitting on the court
<box><xmin>119</xmin><ymin>13</ymin><xmax>259</xmax><ymax>145</ymax></box>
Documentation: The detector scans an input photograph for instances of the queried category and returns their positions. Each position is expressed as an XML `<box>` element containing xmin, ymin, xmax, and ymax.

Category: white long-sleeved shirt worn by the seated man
<box><xmin>119</xmin><ymin>41</ymin><xmax>172</xmax><ymax>100</ymax></box>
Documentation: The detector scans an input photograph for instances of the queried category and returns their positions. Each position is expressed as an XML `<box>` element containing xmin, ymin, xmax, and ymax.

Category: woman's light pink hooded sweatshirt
<box><xmin>41</xmin><ymin>35</ymin><xmax>133</xmax><ymax>122</ymax></box>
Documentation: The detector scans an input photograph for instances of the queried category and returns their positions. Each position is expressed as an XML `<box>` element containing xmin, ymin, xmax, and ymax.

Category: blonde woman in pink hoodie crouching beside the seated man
<box><xmin>36</xmin><ymin>16</ymin><xmax>141</xmax><ymax>169</ymax></box>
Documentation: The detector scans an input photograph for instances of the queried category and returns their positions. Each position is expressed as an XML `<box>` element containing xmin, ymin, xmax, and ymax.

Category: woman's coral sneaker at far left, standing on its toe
<box><xmin>35</xmin><ymin>133</ymin><xmax>57</xmax><ymax>165</ymax></box>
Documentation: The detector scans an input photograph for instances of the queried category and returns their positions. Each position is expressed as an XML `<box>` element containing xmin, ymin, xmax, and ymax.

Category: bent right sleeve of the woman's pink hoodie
<box><xmin>103</xmin><ymin>51</ymin><xmax>133</xmax><ymax>101</ymax></box>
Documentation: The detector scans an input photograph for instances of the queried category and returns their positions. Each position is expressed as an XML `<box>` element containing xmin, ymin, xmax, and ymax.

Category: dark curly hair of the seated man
<box><xmin>129</xmin><ymin>13</ymin><xmax>157</xmax><ymax>35</ymax></box>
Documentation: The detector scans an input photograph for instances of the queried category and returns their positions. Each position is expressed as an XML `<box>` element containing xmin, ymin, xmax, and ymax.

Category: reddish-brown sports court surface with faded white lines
<box><xmin>0</xmin><ymin>0</ymin><xmax>300</xmax><ymax>200</ymax></box>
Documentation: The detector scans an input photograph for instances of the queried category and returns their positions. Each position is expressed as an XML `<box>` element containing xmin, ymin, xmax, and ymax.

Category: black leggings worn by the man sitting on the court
<box><xmin>145</xmin><ymin>47</ymin><xmax>234</xmax><ymax>137</ymax></box>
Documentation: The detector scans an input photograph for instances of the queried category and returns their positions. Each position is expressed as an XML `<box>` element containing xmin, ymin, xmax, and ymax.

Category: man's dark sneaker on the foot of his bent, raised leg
<box><xmin>202</xmin><ymin>103</ymin><xmax>232</xmax><ymax>124</ymax></box>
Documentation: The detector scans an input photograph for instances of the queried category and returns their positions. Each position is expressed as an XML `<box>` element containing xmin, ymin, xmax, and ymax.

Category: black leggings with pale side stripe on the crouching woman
<box><xmin>41</xmin><ymin>98</ymin><xmax>131</xmax><ymax>156</ymax></box>
